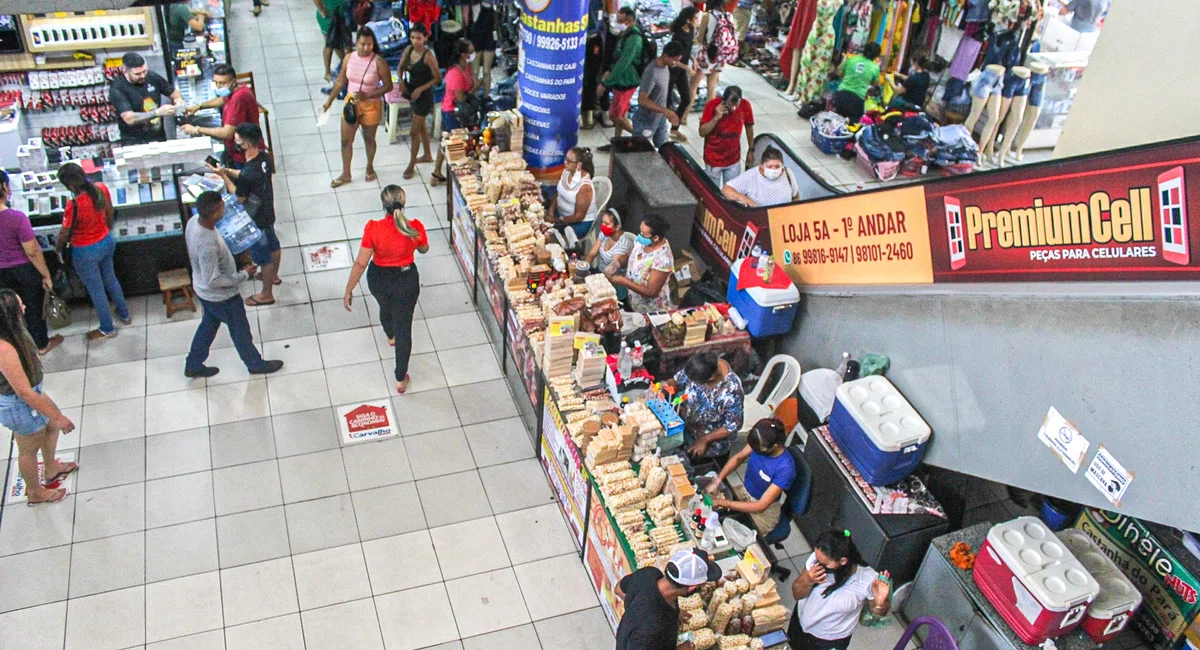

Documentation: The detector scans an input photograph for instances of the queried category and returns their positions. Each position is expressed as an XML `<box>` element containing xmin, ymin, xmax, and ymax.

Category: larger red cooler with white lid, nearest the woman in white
<box><xmin>973</xmin><ymin>517</ymin><xmax>1100</xmax><ymax>645</ymax></box>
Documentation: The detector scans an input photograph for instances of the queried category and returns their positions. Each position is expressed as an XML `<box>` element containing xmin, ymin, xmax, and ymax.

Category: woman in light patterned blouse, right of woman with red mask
<box><xmin>605</xmin><ymin>212</ymin><xmax>674</xmax><ymax>314</ymax></box>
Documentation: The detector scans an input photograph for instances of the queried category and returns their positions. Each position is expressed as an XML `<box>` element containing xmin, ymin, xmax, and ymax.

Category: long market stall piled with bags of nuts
<box><xmin>443</xmin><ymin>128</ymin><xmax>790</xmax><ymax>649</ymax></box>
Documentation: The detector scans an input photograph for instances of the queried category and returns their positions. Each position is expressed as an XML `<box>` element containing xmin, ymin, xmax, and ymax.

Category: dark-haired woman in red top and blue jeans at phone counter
<box><xmin>56</xmin><ymin>163</ymin><xmax>133</xmax><ymax>341</ymax></box>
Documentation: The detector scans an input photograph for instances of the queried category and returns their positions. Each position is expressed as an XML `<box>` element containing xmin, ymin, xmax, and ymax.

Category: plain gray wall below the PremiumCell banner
<box><xmin>779</xmin><ymin>283</ymin><xmax>1200</xmax><ymax>530</ymax></box>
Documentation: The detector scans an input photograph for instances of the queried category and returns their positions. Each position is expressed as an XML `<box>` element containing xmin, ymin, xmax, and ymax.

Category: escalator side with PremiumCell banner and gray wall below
<box><xmin>660</xmin><ymin>134</ymin><xmax>1200</xmax><ymax>530</ymax></box>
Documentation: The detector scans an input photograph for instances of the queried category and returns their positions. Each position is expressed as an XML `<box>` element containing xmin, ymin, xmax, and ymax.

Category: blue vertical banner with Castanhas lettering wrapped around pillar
<box><xmin>517</xmin><ymin>0</ymin><xmax>588</xmax><ymax>177</ymax></box>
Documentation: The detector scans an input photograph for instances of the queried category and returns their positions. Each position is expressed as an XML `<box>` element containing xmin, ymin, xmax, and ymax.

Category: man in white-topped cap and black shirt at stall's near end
<box><xmin>617</xmin><ymin>548</ymin><xmax>721</xmax><ymax>650</ymax></box>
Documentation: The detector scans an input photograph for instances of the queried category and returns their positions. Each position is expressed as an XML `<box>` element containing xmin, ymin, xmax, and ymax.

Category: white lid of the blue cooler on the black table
<box><xmin>838</xmin><ymin>375</ymin><xmax>932</xmax><ymax>452</ymax></box>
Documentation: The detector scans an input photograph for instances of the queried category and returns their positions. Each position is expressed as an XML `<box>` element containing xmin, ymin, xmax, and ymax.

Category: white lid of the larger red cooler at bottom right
<box><xmin>988</xmin><ymin>517</ymin><xmax>1099</xmax><ymax>610</ymax></box>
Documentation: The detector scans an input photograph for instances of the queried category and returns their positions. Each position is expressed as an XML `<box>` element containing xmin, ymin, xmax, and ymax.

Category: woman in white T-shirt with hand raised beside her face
<box><xmin>787</xmin><ymin>530</ymin><xmax>892</xmax><ymax>650</ymax></box>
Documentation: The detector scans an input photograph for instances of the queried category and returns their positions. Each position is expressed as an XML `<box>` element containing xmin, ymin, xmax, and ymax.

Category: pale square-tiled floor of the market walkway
<box><xmin>0</xmin><ymin>0</ymin><xmax>926</xmax><ymax>650</ymax></box>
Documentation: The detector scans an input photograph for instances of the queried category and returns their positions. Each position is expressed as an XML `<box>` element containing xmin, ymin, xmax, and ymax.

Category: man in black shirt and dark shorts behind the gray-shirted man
<box><xmin>210</xmin><ymin>122</ymin><xmax>281</xmax><ymax>307</ymax></box>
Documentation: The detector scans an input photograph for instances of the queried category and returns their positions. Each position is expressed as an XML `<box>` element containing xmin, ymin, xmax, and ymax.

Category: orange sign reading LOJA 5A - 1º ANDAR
<box><xmin>768</xmin><ymin>187</ymin><xmax>934</xmax><ymax>285</ymax></box>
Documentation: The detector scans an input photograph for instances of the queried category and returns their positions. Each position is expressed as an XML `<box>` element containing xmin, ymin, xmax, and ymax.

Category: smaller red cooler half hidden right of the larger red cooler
<box><xmin>1058</xmin><ymin>528</ymin><xmax>1141</xmax><ymax>643</ymax></box>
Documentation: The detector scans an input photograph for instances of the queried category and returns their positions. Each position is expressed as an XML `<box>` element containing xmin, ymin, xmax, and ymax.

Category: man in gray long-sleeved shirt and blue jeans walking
<box><xmin>184</xmin><ymin>192</ymin><xmax>283</xmax><ymax>378</ymax></box>
